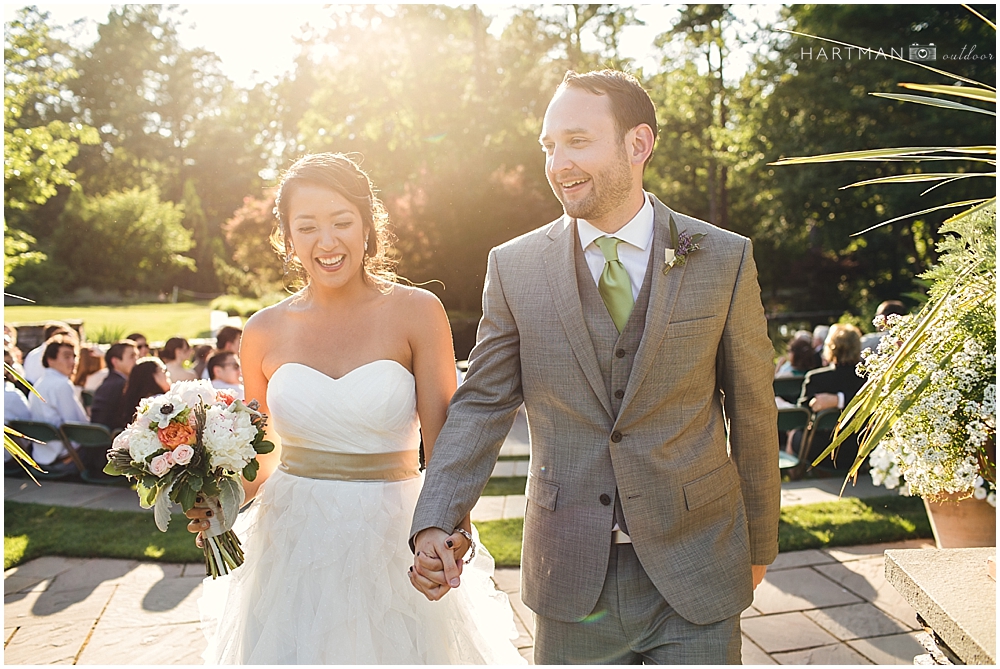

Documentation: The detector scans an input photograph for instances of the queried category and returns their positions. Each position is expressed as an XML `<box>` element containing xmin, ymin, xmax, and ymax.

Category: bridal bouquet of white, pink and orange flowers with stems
<box><xmin>104</xmin><ymin>381</ymin><xmax>274</xmax><ymax>578</ymax></box>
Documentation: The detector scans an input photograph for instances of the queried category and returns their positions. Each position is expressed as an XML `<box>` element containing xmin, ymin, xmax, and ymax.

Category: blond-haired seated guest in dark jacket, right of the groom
<box><xmin>798</xmin><ymin>323</ymin><xmax>865</xmax><ymax>471</ymax></box>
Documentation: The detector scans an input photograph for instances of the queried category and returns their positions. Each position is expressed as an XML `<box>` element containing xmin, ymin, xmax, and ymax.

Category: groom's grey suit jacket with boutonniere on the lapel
<box><xmin>411</xmin><ymin>198</ymin><xmax>780</xmax><ymax>624</ymax></box>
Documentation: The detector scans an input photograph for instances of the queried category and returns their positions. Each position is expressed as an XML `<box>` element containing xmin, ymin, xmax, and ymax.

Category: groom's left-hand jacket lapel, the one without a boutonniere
<box><xmin>543</xmin><ymin>216</ymin><xmax>614</xmax><ymax>418</ymax></box>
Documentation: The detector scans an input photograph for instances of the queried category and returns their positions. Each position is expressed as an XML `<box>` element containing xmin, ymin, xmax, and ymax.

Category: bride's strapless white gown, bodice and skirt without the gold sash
<box><xmin>199</xmin><ymin>360</ymin><xmax>524</xmax><ymax>664</ymax></box>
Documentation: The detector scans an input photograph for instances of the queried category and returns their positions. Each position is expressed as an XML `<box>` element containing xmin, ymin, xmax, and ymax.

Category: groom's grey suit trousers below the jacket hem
<box><xmin>535</xmin><ymin>544</ymin><xmax>742</xmax><ymax>664</ymax></box>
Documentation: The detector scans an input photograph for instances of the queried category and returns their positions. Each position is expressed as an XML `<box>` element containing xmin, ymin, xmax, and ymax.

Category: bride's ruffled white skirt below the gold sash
<box><xmin>199</xmin><ymin>470</ymin><xmax>524</xmax><ymax>664</ymax></box>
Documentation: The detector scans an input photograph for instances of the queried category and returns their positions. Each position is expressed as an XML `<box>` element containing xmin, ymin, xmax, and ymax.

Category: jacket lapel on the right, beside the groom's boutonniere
<box><xmin>618</xmin><ymin>197</ymin><xmax>685</xmax><ymax>416</ymax></box>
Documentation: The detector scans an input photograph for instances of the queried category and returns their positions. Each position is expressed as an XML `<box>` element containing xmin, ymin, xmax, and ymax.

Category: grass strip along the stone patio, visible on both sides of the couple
<box><xmin>3</xmin><ymin>496</ymin><xmax>931</xmax><ymax>569</ymax></box>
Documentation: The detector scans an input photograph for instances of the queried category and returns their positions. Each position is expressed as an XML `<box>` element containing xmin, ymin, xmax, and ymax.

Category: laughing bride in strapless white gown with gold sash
<box><xmin>188</xmin><ymin>153</ymin><xmax>523</xmax><ymax>664</ymax></box>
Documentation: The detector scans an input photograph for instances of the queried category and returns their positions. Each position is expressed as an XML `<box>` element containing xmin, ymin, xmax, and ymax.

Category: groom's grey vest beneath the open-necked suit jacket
<box><xmin>573</xmin><ymin>230</ymin><xmax>654</xmax><ymax>533</ymax></box>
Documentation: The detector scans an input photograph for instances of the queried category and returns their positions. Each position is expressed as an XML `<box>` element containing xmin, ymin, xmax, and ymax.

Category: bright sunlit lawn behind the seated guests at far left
<box><xmin>4</xmin><ymin>302</ymin><xmax>230</xmax><ymax>341</ymax></box>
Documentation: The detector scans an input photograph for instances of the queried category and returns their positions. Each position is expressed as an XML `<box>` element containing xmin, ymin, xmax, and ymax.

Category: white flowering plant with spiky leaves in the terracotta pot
<box><xmin>823</xmin><ymin>206</ymin><xmax>996</xmax><ymax>506</ymax></box>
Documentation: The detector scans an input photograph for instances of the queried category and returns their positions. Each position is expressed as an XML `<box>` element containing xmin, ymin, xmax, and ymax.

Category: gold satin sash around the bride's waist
<box><xmin>280</xmin><ymin>444</ymin><xmax>420</xmax><ymax>481</ymax></box>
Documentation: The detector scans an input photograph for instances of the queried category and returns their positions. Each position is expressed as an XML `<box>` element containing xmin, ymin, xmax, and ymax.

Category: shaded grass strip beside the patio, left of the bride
<box><xmin>3</xmin><ymin>501</ymin><xmax>204</xmax><ymax>569</ymax></box>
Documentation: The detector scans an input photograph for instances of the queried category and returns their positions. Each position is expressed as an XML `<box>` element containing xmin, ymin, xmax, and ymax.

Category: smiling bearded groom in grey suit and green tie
<box><xmin>411</xmin><ymin>70</ymin><xmax>780</xmax><ymax>664</ymax></box>
